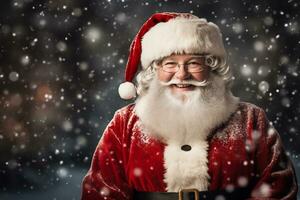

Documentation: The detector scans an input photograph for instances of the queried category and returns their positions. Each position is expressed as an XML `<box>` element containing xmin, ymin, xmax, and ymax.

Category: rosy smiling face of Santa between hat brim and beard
<box><xmin>157</xmin><ymin>55</ymin><xmax>209</xmax><ymax>93</ymax></box>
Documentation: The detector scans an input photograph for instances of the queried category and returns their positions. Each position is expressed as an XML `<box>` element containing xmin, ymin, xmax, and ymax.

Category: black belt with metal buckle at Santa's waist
<box><xmin>133</xmin><ymin>188</ymin><xmax>249</xmax><ymax>200</ymax></box>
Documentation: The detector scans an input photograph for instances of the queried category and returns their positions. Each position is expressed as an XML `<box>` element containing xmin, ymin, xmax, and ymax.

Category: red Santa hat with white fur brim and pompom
<box><xmin>119</xmin><ymin>13</ymin><xmax>226</xmax><ymax>99</ymax></box>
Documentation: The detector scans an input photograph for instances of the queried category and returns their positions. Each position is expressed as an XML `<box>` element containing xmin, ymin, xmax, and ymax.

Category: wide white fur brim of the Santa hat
<box><xmin>141</xmin><ymin>17</ymin><xmax>226</xmax><ymax>68</ymax></box>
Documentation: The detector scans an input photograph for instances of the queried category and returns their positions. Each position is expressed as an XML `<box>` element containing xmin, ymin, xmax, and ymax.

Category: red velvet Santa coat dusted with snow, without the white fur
<box><xmin>82</xmin><ymin>103</ymin><xmax>298</xmax><ymax>200</ymax></box>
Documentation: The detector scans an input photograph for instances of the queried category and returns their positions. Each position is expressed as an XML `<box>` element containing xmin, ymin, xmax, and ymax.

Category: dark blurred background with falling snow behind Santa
<box><xmin>0</xmin><ymin>0</ymin><xmax>300</xmax><ymax>200</ymax></box>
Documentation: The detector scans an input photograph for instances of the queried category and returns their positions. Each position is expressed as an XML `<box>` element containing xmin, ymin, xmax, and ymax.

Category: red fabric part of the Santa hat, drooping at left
<box><xmin>125</xmin><ymin>12</ymin><xmax>179</xmax><ymax>82</ymax></box>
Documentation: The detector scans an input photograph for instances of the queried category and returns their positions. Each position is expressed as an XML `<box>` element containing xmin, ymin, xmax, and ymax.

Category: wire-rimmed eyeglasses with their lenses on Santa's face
<box><xmin>160</xmin><ymin>56</ymin><xmax>205</xmax><ymax>73</ymax></box>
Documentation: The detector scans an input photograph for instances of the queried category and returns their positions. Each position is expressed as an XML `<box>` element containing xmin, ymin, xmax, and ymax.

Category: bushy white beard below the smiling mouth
<box><xmin>135</xmin><ymin>75</ymin><xmax>238</xmax><ymax>144</ymax></box>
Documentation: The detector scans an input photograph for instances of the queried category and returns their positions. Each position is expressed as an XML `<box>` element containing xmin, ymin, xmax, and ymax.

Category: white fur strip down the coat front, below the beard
<box><xmin>164</xmin><ymin>140</ymin><xmax>209</xmax><ymax>192</ymax></box>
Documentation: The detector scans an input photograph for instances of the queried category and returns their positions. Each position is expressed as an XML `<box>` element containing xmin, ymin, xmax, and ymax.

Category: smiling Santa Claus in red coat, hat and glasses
<box><xmin>82</xmin><ymin>13</ymin><xmax>298</xmax><ymax>200</ymax></box>
